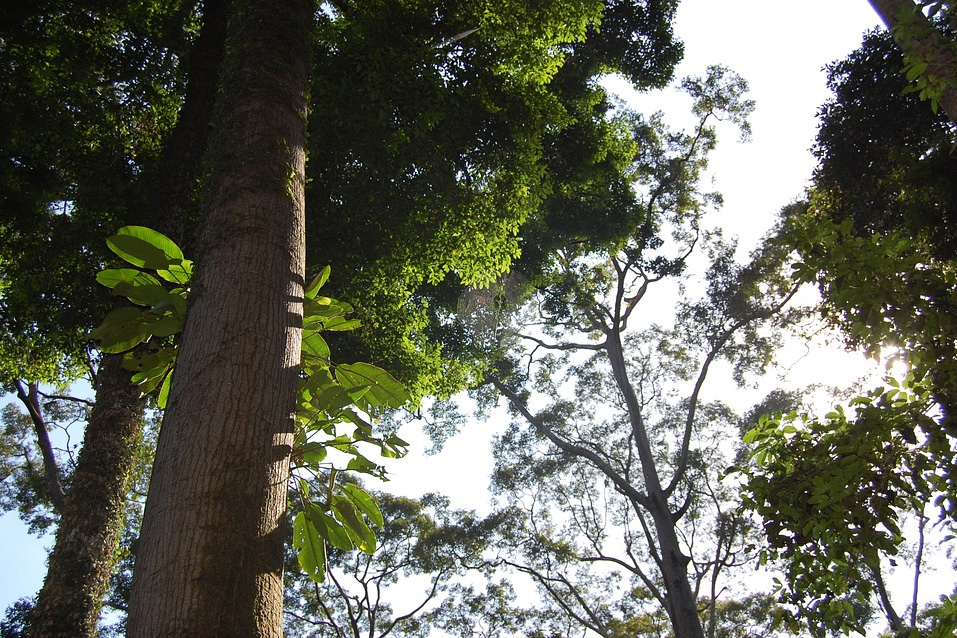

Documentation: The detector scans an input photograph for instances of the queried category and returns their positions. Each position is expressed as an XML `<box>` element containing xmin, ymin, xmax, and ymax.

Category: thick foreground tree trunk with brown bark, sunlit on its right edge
<box><xmin>127</xmin><ymin>0</ymin><xmax>312</xmax><ymax>638</ymax></box>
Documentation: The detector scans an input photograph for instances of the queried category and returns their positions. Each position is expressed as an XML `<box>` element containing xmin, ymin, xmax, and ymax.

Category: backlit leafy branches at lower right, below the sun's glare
<box><xmin>743</xmin><ymin>375</ymin><xmax>940</xmax><ymax>635</ymax></box>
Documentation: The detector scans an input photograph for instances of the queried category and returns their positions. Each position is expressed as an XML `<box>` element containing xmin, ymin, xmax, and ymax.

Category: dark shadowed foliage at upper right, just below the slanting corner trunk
<box><xmin>814</xmin><ymin>31</ymin><xmax>957</xmax><ymax>259</ymax></box>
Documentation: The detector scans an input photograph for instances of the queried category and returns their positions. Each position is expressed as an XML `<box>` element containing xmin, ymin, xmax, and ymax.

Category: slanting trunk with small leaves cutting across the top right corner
<box><xmin>868</xmin><ymin>0</ymin><xmax>957</xmax><ymax>124</ymax></box>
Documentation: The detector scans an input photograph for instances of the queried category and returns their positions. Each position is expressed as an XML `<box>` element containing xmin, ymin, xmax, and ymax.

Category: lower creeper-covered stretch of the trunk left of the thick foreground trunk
<box><xmin>30</xmin><ymin>355</ymin><xmax>143</xmax><ymax>638</ymax></box>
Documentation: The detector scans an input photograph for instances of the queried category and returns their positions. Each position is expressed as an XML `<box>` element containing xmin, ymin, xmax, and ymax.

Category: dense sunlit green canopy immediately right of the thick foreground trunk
<box><xmin>307</xmin><ymin>2</ymin><xmax>680</xmax><ymax>395</ymax></box>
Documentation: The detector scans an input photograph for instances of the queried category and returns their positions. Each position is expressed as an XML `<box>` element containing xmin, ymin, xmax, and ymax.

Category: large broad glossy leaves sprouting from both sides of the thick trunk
<box><xmin>91</xmin><ymin>226</ymin><xmax>410</xmax><ymax>581</ymax></box>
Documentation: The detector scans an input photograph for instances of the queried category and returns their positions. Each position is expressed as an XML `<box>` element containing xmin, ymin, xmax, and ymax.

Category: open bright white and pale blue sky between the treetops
<box><xmin>0</xmin><ymin>0</ymin><xmax>879</xmax><ymax>624</ymax></box>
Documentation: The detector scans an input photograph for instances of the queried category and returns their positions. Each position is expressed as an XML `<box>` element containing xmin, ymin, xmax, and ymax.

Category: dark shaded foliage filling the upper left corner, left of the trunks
<box><xmin>0</xmin><ymin>2</ymin><xmax>193</xmax><ymax>380</ymax></box>
